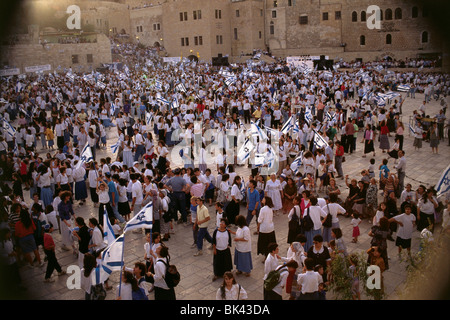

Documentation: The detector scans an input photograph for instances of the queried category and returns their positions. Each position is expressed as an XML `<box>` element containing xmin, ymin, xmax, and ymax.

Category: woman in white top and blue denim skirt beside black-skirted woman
<box><xmin>234</xmin><ymin>215</ymin><xmax>253</xmax><ymax>277</ymax></box>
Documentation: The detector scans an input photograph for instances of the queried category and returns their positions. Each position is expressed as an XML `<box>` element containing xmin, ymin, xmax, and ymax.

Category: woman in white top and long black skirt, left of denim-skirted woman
<box><xmin>212</xmin><ymin>219</ymin><xmax>233</xmax><ymax>281</ymax></box>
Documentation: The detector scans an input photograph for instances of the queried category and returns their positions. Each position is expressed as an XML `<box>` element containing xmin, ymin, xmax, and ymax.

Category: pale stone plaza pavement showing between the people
<box><xmin>12</xmin><ymin>93</ymin><xmax>450</xmax><ymax>300</ymax></box>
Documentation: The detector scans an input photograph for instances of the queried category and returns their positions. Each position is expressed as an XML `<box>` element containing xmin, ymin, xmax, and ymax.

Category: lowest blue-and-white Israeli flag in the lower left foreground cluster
<box><xmin>92</xmin><ymin>234</ymin><xmax>125</xmax><ymax>285</ymax></box>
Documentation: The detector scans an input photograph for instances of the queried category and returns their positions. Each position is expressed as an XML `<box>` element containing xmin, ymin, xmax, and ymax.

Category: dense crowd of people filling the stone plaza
<box><xmin>0</xmin><ymin>40</ymin><xmax>450</xmax><ymax>300</ymax></box>
